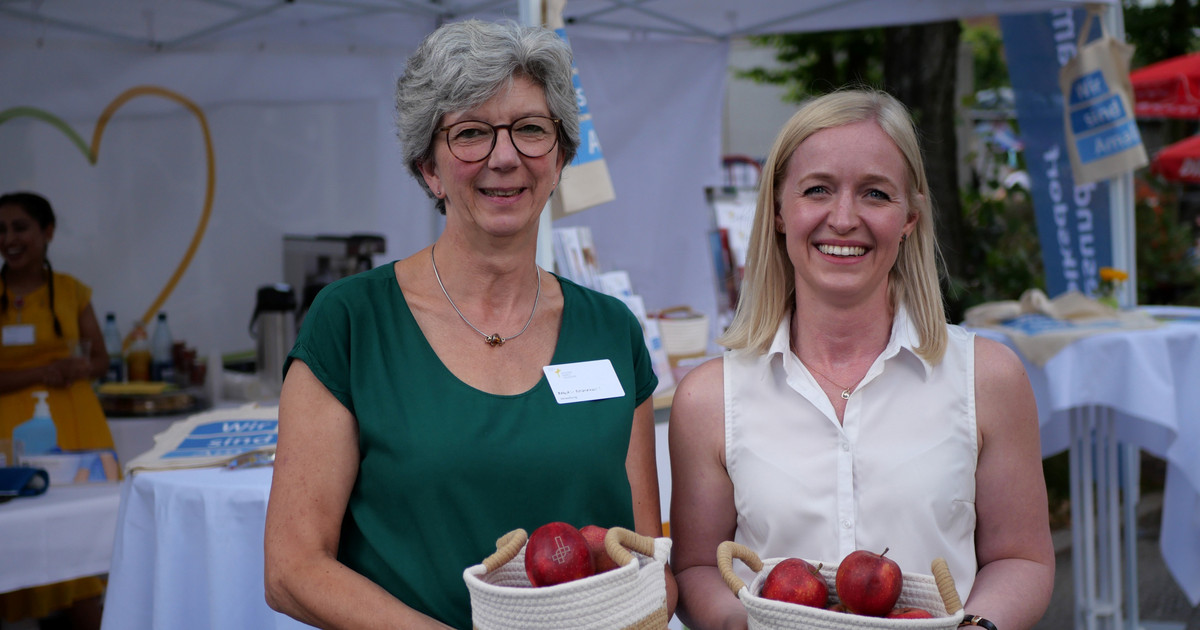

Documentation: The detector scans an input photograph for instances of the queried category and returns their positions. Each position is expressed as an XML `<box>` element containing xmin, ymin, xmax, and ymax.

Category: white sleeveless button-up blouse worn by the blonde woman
<box><xmin>725</xmin><ymin>308</ymin><xmax>979</xmax><ymax>601</ymax></box>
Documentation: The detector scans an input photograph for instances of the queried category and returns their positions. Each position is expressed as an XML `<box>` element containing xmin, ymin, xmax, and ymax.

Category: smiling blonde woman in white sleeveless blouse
<box><xmin>670</xmin><ymin>90</ymin><xmax>1054</xmax><ymax>630</ymax></box>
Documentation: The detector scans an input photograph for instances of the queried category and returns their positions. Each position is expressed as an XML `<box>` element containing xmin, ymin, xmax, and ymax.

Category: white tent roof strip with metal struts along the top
<box><xmin>0</xmin><ymin>0</ymin><xmax>1108</xmax><ymax>49</ymax></box>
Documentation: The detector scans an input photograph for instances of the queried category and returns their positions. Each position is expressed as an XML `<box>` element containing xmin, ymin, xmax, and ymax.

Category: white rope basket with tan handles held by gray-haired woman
<box><xmin>462</xmin><ymin>527</ymin><xmax>671</xmax><ymax>630</ymax></box>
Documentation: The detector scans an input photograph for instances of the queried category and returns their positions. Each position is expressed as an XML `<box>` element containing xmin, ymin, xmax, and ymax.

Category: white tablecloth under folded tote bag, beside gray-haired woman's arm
<box><xmin>102</xmin><ymin>468</ymin><xmax>310</xmax><ymax>630</ymax></box>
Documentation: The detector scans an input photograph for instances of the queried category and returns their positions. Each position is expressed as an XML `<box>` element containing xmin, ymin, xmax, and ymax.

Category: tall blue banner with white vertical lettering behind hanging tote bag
<box><xmin>1000</xmin><ymin>8</ymin><xmax>1108</xmax><ymax>298</ymax></box>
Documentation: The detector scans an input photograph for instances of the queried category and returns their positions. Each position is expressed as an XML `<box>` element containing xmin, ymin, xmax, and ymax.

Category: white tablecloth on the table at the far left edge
<box><xmin>0</xmin><ymin>484</ymin><xmax>120</xmax><ymax>593</ymax></box>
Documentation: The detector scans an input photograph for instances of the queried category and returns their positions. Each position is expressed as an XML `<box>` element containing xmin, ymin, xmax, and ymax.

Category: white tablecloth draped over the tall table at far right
<box><xmin>977</xmin><ymin>308</ymin><xmax>1200</xmax><ymax>605</ymax></box>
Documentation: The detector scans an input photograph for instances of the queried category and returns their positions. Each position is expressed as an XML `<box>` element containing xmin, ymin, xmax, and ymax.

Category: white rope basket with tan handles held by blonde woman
<box><xmin>716</xmin><ymin>541</ymin><xmax>962</xmax><ymax>630</ymax></box>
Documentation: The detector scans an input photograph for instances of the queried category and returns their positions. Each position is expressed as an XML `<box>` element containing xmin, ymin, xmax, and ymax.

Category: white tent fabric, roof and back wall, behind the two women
<box><xmin>0</xmin><ymin>0</ymin><xmax>1113</xmax><ymax>354</ymax></box>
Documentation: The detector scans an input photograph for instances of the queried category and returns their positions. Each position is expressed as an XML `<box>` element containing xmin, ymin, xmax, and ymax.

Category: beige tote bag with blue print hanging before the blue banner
<box><xmin>1058</xmin><ymin>6</ymin><xmax>1150</xmax><ymax>186</ymax></box>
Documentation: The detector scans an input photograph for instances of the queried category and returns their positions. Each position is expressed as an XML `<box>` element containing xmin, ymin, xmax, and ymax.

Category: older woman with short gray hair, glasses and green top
<box><xmin>265</xmin><ymin>20</ymin><xmax>662</xmax><ymax>629</ymax></box>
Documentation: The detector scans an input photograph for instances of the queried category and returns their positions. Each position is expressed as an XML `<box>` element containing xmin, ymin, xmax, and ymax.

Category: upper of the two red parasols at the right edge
<box><xmin>1129</xmin><ymin>53</ymin><xmax>1200</xmax><ymax>120</ymax></box>
